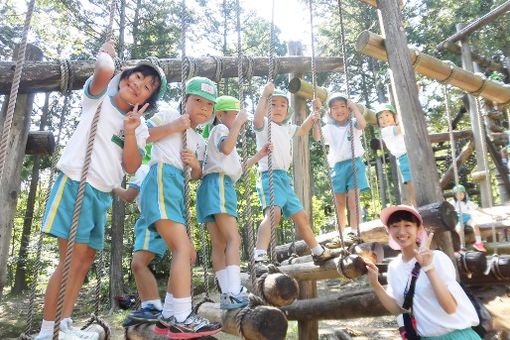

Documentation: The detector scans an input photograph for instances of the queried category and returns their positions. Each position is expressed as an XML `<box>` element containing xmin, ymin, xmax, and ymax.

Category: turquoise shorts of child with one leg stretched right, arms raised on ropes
<box><xmin>257</xmin><ymin>170</ymin><xmax>303</xmax><ymax>217</ymax></box>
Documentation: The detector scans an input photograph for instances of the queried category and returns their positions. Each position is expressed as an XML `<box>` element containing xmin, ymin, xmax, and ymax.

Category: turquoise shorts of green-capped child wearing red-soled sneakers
<box><xmin>140</xmin><ymin>162</ymin><xmax>186</xmax><ymax>230</ymax></box>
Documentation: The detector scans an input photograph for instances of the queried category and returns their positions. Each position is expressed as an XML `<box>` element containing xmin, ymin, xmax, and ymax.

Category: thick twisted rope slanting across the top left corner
<box><xmin>0</xmin><ymin>0</ymin><xmax>35</xmax><ymax>181</ymax></box>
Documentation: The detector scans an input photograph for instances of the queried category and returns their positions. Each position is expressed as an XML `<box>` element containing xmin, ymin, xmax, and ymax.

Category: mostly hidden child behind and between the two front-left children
<box><xmin>113</xmin><ymin>144</ymin><xmax>167</xmax><ymax>327</ymax></box>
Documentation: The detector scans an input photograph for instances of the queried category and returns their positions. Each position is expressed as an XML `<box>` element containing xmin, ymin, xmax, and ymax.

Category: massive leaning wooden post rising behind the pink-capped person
<box><xmin>377</xmin><ymin>0</ymin><xmax>456</xmax><ymax>263</ymax></box>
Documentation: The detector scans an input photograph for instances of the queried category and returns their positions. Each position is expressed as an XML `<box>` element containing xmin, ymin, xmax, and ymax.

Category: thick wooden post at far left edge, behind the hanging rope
<box><xmin>0</xmin><ymin>44</ymin><xmax>43</xmax><ymax>296</ymax></box>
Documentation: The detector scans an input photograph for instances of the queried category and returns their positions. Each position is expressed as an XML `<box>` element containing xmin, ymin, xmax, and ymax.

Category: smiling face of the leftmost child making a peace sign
<box><xmin>118</xmin><ymin>72</ymin><xmax>160</xmax><ymax>106</ymax></box>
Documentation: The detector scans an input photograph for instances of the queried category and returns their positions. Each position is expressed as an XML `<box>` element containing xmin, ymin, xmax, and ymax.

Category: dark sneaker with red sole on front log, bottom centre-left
<box><xmin>154</xmin><ymin>312</ymin><xmax>221</xmax><ymax>339</ymax></box>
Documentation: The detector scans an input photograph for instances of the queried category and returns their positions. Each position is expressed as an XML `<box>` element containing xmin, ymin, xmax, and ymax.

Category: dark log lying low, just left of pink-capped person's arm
<box><xmin>282</xmin><ymin>289</ymin><xmax>390</xmax><ymax>320</ymax></box>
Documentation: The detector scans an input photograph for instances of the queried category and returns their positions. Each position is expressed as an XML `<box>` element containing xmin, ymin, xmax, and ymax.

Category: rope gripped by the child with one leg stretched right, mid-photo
<box><xmin>262</xmin><ymin>0</ymin><xmax>277</xmax><ymax>263</ymax></box>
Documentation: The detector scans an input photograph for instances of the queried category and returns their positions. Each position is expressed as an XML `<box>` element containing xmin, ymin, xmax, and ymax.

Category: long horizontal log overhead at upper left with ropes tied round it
<box><xmin>0</xmin><ymin>57</ymin><xmax>343</xmax><ymax>94</ymax></box>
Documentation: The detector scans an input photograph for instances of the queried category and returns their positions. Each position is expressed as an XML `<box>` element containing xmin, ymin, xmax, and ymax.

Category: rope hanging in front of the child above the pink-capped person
<box><xmin>338</xmin><ymin>0</ymin><xmax>361</xmax><ymax>239</ymax></box>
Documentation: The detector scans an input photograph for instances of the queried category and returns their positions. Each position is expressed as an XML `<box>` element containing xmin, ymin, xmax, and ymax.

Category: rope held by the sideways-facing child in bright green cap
<box><xmin>236</xmin><ymin>0</ymin><xmax>258</xmax><ymax>294</ymax></box>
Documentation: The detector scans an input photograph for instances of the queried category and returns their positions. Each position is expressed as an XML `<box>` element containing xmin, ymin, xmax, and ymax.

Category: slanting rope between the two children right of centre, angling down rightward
<box><xmin>308</xmin><ymin>0</ymin><xmax>345</xmax><ymax>248</ymax></box>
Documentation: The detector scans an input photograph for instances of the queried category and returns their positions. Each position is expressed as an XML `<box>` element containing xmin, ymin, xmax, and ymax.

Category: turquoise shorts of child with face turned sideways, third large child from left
<box><xmin>197</xmin><ymin>172</ymin><xmax>237</xmax><ymax>223</ymax></box>
